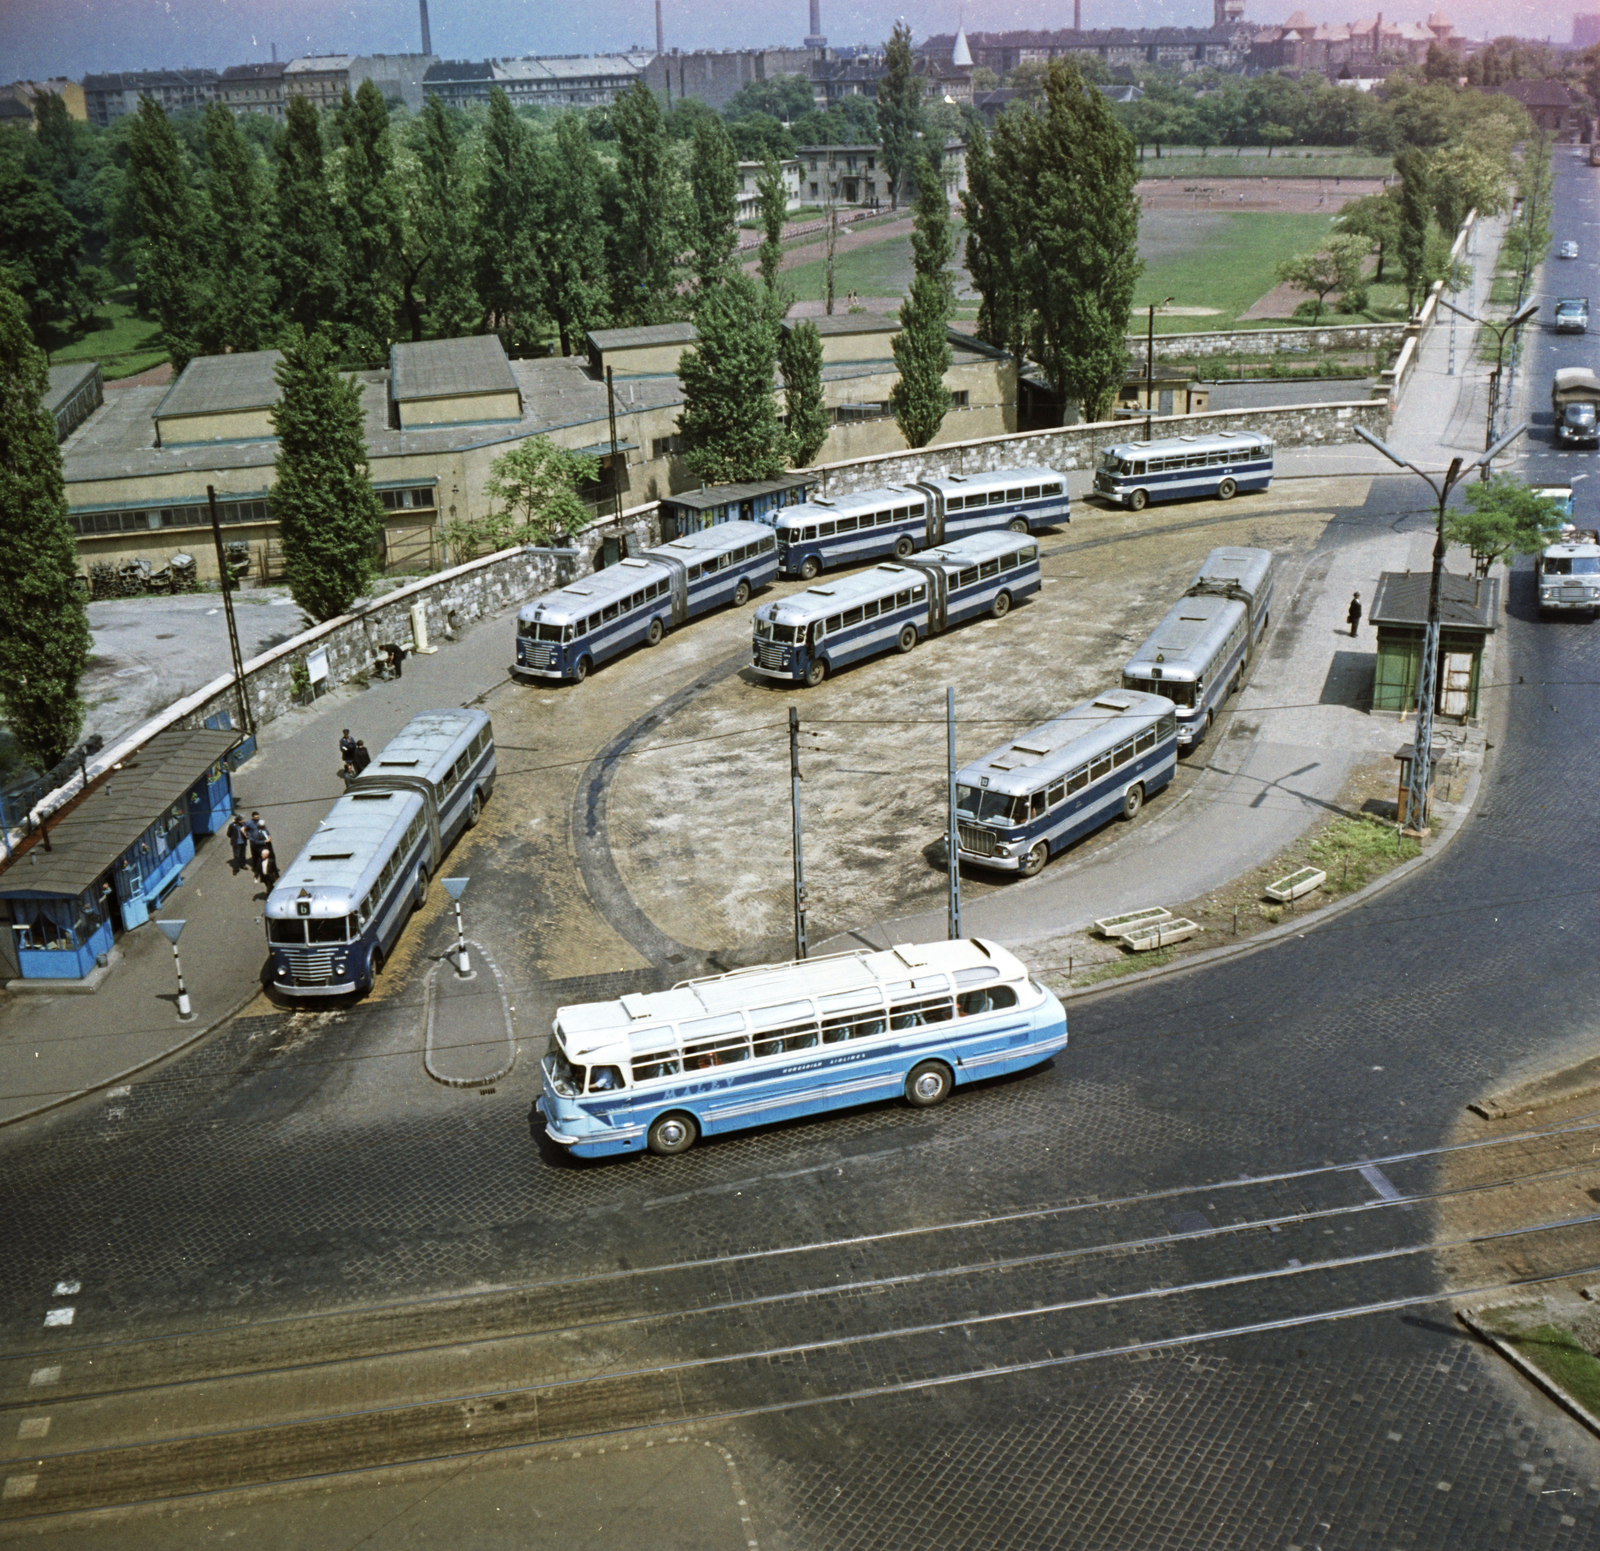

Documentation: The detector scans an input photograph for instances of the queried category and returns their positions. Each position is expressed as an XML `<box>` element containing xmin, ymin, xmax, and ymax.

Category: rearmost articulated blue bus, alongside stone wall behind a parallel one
<box><xmin>778</xmin><ymin>469</ymin><xmax>1070</xmax><ymax>581</ymax></box>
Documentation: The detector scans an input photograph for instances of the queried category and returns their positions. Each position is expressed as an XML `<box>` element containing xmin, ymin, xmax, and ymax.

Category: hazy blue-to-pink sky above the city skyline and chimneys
<box><xmin>0</xmin><ymin>0</ymin><xmax>1574</xmax><ymax>80</ymax></box>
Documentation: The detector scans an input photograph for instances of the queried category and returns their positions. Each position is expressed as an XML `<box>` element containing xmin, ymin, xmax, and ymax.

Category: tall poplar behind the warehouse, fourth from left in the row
<box><xmin>338</xmin><ymin>80</ymin><xmax>400</xmax><ymax>362</ymax></box>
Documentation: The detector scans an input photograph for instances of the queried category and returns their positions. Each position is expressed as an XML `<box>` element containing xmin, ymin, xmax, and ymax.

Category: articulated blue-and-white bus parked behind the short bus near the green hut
<box><xmin>1122</xmin><ymin>549</ymin><xmax>1277</xmax><ymax>749</ymax></box>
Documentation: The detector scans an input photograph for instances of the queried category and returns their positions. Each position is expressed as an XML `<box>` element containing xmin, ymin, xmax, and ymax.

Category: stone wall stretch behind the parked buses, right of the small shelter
<box><xmin>818</xmin><ymin>399</ymin><xmax>1389</xmax><ymax>495</ymax></box>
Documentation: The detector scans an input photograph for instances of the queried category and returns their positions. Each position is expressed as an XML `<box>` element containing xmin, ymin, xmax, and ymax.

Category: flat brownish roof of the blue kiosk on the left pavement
<box><xmin>0</xmin><ymin>728</ymin><xmax>242</xmax><ymax>895</ymax></box>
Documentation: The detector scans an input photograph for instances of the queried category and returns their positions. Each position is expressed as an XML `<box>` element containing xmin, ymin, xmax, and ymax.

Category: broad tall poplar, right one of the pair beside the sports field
<box><xmin>1024</xmin><ymin>59</ymin><xmax>1142</xmax><ymax>419</ymax></box>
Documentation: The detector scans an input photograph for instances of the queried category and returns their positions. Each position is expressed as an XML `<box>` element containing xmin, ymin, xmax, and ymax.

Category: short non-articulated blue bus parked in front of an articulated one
<box><xmin>955</xmin><ymin>690</ymin><xmax>1178</xmax><ymax>877</ymax></box>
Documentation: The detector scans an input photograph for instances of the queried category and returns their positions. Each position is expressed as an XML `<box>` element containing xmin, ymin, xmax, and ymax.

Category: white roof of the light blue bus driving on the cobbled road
<box><xmin>555</xmin><ymin>938</ymin><xmax>1027</xmax><ymax>1063</ymax></box>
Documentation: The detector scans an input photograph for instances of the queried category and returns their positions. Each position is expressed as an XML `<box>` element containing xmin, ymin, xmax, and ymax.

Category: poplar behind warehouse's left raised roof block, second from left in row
<box><xmin>198</xmin><ymin>102</ymin><xmax>272</xmax><ymax>355</ymax></box>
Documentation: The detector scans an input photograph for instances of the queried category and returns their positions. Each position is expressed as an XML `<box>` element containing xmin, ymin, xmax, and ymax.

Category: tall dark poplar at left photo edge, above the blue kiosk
<box><xmin>0</xmin><ymin>277</ymin><xmax>90</xmax><ymax>770</ymax></box>
